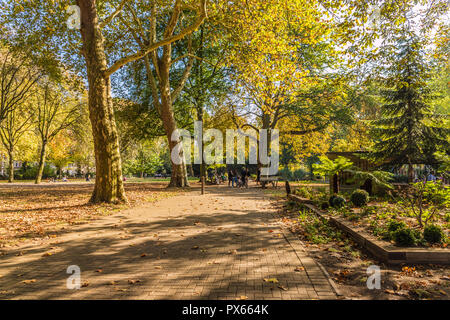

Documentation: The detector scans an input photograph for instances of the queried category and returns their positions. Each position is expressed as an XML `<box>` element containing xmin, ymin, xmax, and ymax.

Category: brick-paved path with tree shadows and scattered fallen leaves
<box><xmin>0</xmin><ymin>186</ymin><xmax>336</xmax><ymax>300</ymax></box>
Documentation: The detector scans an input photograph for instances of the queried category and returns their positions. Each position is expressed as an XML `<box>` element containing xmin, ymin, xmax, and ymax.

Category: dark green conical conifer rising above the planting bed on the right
<box><xmin>372</xmin><ymin>31</ymin><xmax>450</xmax><ymax>181</ymax></box>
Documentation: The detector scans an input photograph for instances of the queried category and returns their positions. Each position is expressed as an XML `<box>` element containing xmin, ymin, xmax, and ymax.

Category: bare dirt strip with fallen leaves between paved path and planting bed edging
<box><xmin>277</xmin><ymin>195</ymin><xmax>450</xmax><ymax>300</ymax></box>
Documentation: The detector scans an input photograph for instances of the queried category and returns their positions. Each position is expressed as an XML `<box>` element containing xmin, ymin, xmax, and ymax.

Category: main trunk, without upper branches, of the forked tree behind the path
<box><xmin>159</xmin><ymin>46</ymin><xmax>189</xmax><ymax>188</ymax></box>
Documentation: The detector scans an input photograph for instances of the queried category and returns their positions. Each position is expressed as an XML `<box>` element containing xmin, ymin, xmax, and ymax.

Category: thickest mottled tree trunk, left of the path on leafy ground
<box><xmin>77</xmin><ymin>0</ymin><xmax>127</xmax><ymax>203</ymax></box>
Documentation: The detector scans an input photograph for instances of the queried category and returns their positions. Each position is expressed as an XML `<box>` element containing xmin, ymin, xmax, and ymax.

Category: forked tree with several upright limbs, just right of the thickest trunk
<box><xmin>122</xmin><ymin>0</ymin><xmax>206</xmax><ymax>187</ymax></box>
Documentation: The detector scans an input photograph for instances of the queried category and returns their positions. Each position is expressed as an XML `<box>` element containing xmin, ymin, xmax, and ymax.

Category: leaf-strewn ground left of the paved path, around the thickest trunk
<box><xmin>0</xmin><ymin>182</ymin><xmax>183</xmax><ymax>248</ymax></box>
